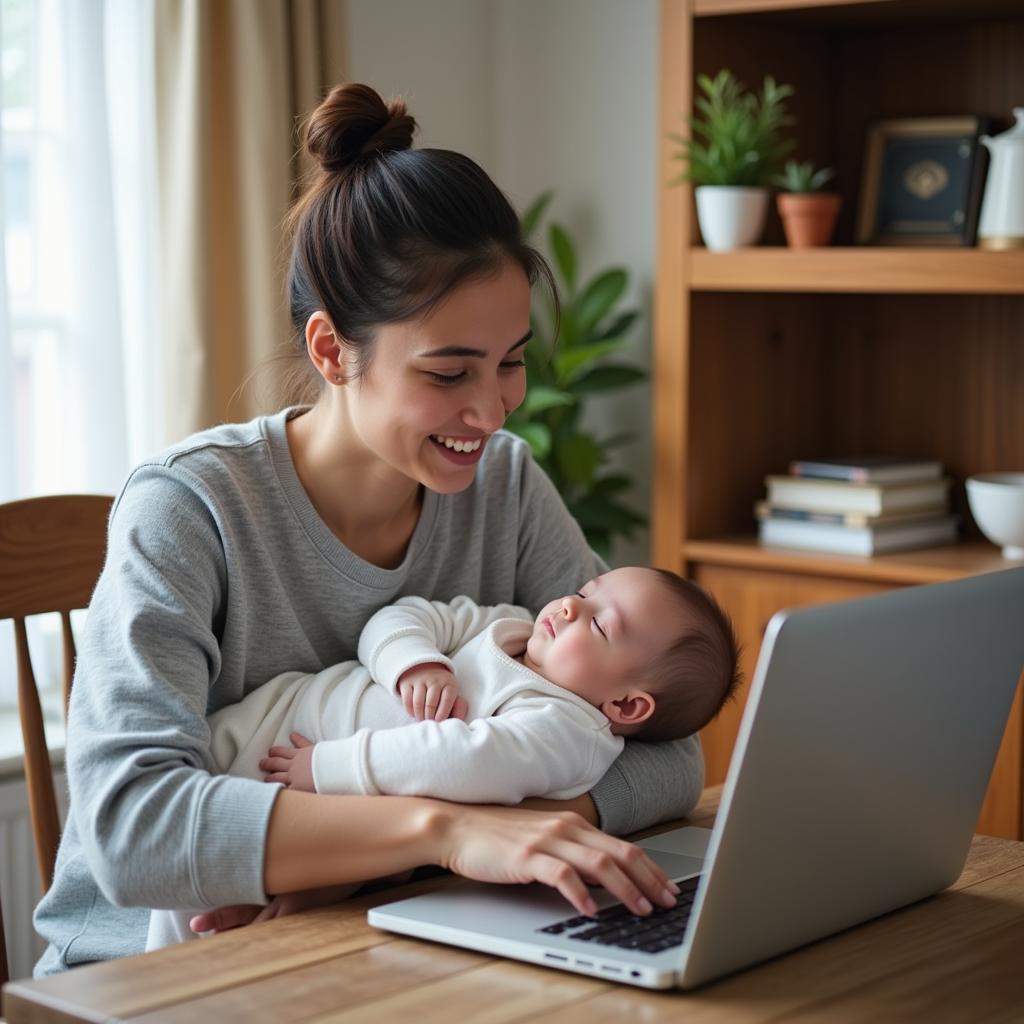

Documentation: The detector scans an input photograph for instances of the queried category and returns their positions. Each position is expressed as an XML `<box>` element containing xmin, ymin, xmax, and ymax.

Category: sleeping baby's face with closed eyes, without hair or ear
<box><xmin>525</xmin><ymin>566</ymin><xmax>682</xmax><ymax>708</ymax></box>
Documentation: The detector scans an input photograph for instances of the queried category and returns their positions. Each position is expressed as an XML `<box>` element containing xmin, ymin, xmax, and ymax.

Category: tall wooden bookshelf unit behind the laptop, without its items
<box><xmin>652</xmin><ymin>0</ymin><xmax>1024</xmax><ymax>839</ymax></box>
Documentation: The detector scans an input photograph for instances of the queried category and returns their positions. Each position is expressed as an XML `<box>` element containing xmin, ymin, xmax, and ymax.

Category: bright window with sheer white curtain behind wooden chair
<box><xmin>0</xmin><ymin>0</ymin><xmax>161</xmax><ymax>707</ymax></box>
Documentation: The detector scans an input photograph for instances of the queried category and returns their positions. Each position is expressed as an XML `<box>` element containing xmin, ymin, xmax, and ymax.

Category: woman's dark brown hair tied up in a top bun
<box><xmin>288</xmin><ymin>84</ymin><xmax>554</xmax><ymax>395</ymax></box>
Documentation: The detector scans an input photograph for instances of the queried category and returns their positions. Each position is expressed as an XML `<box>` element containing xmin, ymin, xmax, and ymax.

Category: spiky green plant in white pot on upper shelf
<box><xmin>670</xmin><ymin>69</ymin><xmax>794</xmax><ymax>252</ymax></box>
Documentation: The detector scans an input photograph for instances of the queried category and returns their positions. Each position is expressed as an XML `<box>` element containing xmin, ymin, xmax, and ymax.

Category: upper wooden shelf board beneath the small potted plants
<box><xmin>689</xmin><ymin>246</ymin><xmax>1024</xmax><ymax>295</ymax></box>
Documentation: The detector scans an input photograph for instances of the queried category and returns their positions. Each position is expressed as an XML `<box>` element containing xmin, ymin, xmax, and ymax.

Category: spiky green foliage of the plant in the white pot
<box><xmin>669</xmin><ymin>69</ymin><xmax>795</xmax><ymax>186</ymax></box>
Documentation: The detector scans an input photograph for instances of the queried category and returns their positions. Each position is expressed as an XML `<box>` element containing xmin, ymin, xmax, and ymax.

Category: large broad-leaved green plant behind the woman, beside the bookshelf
<box><xmin>506</xmin><ymin>191</ymin><xmax>647</xmax><ymax>556</ymax></box>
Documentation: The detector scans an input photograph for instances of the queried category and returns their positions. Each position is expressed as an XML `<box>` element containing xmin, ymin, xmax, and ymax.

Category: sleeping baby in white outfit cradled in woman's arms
<box><xmin>147</xmin><ymin>567</ymin><xmax>738</xmax><ymax>948</ymax></box>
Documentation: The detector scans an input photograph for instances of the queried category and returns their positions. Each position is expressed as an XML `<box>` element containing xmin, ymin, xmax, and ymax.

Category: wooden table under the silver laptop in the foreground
<box><xmin>3</xmin><ymin>787</ymin><xmax>1024</xmax><ymax>1024</ymax></box>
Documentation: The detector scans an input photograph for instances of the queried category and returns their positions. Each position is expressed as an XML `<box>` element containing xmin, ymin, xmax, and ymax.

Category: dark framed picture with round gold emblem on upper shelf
<box><xmin>856</xmin><ymin>116</ymin><xmax>988</xmax><ymax>246</ymax></box>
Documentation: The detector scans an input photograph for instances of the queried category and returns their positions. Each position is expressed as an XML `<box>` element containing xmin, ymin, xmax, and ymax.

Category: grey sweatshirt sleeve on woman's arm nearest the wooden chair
<box><xmin>68</xmin><ymin>466</ymin><xmax>275</xmax><ymax>907</ymax></box>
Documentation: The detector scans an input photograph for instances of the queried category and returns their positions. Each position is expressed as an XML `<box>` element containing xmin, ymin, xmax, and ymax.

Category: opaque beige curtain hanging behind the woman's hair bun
<box><xmin>155</xmin><ymin>0</ymin><xmax>343</xmax><ymax>441</ymax></box>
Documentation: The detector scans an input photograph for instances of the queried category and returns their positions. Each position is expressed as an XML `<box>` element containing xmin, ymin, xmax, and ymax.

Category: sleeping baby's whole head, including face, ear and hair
<box><xmin>523</xmin><ymin>566</ymin><xmax>738</xmax><ymax>739</ymax></box>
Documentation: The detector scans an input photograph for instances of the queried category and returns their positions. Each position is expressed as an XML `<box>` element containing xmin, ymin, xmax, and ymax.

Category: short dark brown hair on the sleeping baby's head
<box><xmin>633</xmin><ymin>569</ymin><xmax>740</xmax><ymax>740</ymax></box>
